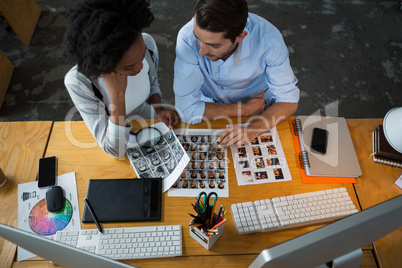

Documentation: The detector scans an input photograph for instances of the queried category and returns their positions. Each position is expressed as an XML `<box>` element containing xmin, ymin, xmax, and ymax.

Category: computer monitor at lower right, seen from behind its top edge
<box><xmin>250</xmin><ymin>195</ymin><xmax>402</xmax><ymax>268</ymax></box>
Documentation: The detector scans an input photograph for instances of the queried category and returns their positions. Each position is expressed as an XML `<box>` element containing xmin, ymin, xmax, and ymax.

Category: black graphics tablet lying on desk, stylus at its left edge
<box><xmin>82</xmin><ymin>178</ymin><xmax>162</xmax><ymax>223</ymax></box>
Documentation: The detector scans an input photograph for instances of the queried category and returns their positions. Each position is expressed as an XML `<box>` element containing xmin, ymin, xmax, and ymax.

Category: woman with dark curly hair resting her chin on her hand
<box><xmin>64</xmin><ymin>0</ymin><xmax>179</xmax><ymax>157</ymax></box>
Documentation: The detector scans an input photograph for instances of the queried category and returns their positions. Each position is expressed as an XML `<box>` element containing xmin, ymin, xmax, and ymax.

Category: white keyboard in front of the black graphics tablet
<box><xmin>55</xmin><ymin>225</ymin><xmax>182</xmax><ymax>260</ymax></box>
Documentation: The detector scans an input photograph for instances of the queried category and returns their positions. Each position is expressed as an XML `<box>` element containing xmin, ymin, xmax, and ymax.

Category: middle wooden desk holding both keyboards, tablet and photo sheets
<box><xmin>15</xmin><ymin>121</ymin><xmax>376</xmax><ymax>267</ymax></box>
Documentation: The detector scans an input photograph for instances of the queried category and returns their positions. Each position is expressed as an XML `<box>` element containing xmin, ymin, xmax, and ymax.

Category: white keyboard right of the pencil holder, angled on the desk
<box><xmin>231</xmin><ymin>187</ymin><xmax>358</xmax><ymax>234</ymax></box>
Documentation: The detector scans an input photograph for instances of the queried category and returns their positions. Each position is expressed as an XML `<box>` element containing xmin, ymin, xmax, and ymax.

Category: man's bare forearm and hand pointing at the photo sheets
<box><xmin>218</xmin><ymin>102</ymin><xmax>298</xmax><ymax>147</ymax></box>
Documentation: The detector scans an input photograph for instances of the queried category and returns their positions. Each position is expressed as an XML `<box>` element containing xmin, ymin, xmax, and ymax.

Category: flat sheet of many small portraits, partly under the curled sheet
<box><xmin>168</xmin><ymin>129</ymin><xmax>229</xmax><ymax>197</ymax></box>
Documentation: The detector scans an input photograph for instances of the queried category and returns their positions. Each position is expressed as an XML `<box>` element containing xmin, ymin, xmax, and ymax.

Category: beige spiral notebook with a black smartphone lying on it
<box><xmin>294</xmin><ymin>116</ymin><xmax>362</xmax><ymax>177</ymax></box>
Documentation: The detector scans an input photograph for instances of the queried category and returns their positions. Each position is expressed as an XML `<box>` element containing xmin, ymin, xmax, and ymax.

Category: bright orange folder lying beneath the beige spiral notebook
<box><xmin>290</xmin><ymin>120</ymin><xmax>356</xmax><ymax>183</ymax></box>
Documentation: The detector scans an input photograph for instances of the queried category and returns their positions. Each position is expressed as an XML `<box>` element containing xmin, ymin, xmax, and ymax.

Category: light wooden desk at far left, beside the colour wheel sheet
<box><xmin>0</xmin><ymin>122</ymin><xmax>52</xmax><ymax>267</ymax></box>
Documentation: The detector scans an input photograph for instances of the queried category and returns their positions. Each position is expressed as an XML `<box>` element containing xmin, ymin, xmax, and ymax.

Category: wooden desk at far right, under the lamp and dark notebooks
<box><xmin>347</xmin><ymin>119</ymin><xmax>402</xmax><ymax>267</ymax></box>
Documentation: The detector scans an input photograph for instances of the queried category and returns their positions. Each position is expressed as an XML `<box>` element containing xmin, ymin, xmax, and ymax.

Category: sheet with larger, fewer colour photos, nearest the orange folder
<box><xmin>230</xmin><ymin>128</ymin><xmax>292</xmax><ymax>185</ymax></box>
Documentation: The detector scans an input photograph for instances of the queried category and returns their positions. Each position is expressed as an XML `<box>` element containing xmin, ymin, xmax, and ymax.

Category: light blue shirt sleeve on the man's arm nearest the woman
<box><xmin>173</xmin><ymin>26</ymin><xmax>205</xmax><ymax>124</ymax></box>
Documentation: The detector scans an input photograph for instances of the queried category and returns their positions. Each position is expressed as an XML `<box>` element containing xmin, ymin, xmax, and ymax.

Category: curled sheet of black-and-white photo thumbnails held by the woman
<box><xmin>126</xmin><ymin>123</ymin><xmax>189</xmax><ymax>192</ymax></box>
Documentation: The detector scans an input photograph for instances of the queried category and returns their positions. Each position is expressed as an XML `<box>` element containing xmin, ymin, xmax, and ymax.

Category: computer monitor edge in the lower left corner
<box><xmin>0</xmin><ymin>223</ymin><xmax>133</xmax><ymax>268</ymax></box>
